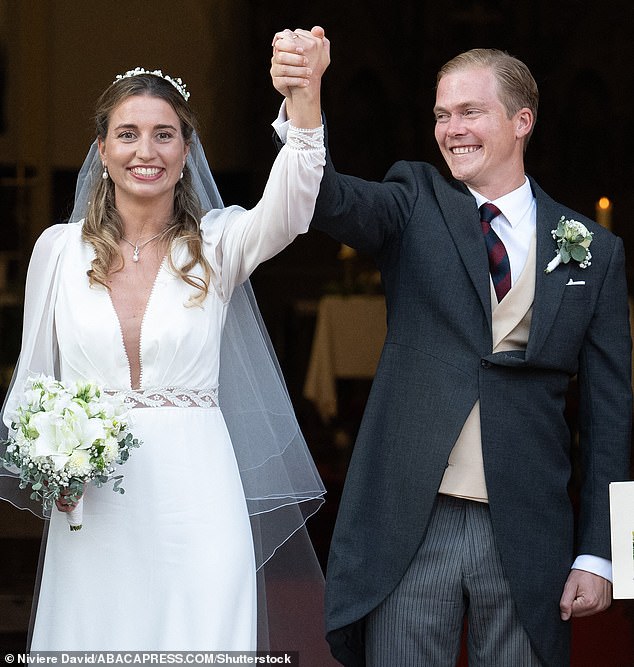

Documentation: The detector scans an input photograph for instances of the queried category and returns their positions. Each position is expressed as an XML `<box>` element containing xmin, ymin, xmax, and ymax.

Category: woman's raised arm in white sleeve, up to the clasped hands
<box><xmin>202</xmin><ymin>29</ymin><xmax>330</xmax><ymax>299</ymax></box>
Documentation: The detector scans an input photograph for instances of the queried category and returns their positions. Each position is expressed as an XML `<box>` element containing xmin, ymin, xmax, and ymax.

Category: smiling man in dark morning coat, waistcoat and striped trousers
<box><xmin>271</xmin><ymin>29</ymin><xmax>632</xmax><ymax>667</ymax></box>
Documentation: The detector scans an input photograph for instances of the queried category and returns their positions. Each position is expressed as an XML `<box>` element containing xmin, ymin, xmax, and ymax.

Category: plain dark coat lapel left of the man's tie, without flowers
<box><xmin>434</xmin><ymin>175</ymin><xmax>491</xmax><ymax>328</ymax></box>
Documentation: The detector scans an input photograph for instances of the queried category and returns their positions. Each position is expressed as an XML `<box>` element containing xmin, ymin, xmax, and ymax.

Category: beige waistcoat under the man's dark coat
<box><xmin>438</xmin><ymin>236</ymin><xmax>535</xmax><ymax>502</ymax></box>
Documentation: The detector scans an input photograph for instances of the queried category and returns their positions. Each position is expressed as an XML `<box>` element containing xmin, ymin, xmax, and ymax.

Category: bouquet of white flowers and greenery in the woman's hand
<box><xmin>0</xmin><ymin>375</ymin><xmax>141</xmax><ymax>530</ymax></box>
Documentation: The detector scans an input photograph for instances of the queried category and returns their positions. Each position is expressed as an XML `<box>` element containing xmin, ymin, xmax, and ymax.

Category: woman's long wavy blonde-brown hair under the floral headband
<box><xmin>82</xmin><ymin>74</ymin><xmax>212</xmax><ymax>303</ymax></box>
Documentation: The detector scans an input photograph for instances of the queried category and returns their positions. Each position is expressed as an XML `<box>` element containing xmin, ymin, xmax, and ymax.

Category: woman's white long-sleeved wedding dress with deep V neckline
<box><xmin>5</xmin><ymin>128</ymin><xmax>324</xmax><ymax>651</ymax></box>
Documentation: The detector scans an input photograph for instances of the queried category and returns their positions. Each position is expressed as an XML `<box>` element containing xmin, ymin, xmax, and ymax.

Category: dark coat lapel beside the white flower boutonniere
<box><xmin>526</xmin><ymin>179</ymin><xmax>570</xmax><ymax>360</ymax></box>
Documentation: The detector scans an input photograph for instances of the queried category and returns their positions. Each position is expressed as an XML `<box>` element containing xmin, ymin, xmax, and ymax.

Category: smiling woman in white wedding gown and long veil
<box><xmin>0</xmin><ymin>30</ymin><xmax>329</xmax><ymax>664</ymax></box>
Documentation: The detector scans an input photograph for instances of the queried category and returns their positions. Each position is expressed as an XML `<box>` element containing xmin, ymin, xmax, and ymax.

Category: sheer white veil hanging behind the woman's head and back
<box><xmin>0</xmin><ymin>126</ymin><xmax>326</xmax><ymax>664</ymax></box>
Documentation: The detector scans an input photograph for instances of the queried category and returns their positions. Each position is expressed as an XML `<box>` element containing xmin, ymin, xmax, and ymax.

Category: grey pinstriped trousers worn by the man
<box><xmin>366</xmin><ymin>495</ymin><xmax>542</xmax><ymax>667</ymax></box>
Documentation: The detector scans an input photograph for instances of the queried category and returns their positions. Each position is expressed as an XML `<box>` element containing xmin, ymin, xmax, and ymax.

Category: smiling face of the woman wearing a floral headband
<box><xmin>99</xmin><ymin>95</ymin><xmax>189</xmax><ymax>204</ymax></box>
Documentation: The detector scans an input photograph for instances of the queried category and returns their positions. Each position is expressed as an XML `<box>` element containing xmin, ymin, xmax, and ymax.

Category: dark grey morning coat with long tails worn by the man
<box><xmin>312</xmin><ymin>145</ymin><xmax>632</xmax><ymax>666</ymax></box>
